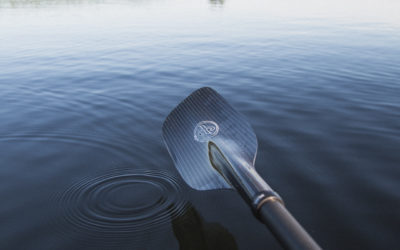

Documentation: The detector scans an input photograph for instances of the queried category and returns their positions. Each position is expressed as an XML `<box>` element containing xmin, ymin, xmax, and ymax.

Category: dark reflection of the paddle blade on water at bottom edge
<box><xmin>172</xmin><ymin>203</ymin><xmax>238</xmax><ymax>250</ymax></box>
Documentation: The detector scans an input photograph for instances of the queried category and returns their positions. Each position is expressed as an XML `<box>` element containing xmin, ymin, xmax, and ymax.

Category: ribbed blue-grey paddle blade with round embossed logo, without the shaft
<box><xmin>163</xmin><ymin>87</ymin><xmax>257</xmax><ymax>190</ymax></box>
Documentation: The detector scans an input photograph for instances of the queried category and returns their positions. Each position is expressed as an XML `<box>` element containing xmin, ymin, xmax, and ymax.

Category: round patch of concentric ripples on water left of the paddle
<box><xmin>56</xmin><ymin>169</ymin><xmax>187</xmax><ymax>245</ymax></box>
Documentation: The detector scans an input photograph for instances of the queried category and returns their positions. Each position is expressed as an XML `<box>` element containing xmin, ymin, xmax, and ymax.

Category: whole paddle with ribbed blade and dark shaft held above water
<box><xmin>162</xmin><ymin>87</ymin><xmax>320</xmax><ymax>249</ymax></box>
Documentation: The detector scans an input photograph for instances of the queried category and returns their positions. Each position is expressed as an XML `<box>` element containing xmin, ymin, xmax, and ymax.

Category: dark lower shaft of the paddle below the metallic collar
<box><xmin>258</xmin><ymin>200</ymin><xmax>321</xmax><ymax>250</ymax></box>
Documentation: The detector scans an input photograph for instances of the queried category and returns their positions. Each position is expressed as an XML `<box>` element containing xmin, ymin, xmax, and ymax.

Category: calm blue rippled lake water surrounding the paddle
<box><xmin>0</xmin><ymin>0</ymin><xmax>400</xmax><ymax>249</ymax></box>
